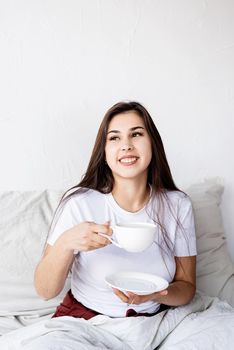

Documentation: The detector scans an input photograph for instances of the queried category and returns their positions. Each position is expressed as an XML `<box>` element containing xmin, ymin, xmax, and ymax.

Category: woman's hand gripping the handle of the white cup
<box><xmin>55</xmin><ymin>222</ymin><xmax>112</xmax><ymax>252</ymax></box>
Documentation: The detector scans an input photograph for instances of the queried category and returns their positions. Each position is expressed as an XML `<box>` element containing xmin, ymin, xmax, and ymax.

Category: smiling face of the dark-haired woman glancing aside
<box><xmin>105</xmin><ymin>111</ymin><xmax>152</xmax><ymax>183</ymax></box>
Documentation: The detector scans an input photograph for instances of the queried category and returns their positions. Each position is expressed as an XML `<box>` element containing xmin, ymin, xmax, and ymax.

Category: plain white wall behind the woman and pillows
<box><xmin>0</xmin><ymin>0</ymin><xmax>234</xmax><ymax>260</ymax></box>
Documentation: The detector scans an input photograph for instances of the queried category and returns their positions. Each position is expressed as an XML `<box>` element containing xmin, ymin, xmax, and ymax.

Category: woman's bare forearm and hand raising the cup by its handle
<box><xmin>34</xmin><ymin>222</ymin><xmax>112</xmax><ymax>300</ymax></box>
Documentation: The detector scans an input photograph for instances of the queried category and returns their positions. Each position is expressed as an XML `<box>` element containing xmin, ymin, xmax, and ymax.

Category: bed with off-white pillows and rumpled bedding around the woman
<box><xmin>0</xmin><ymin>180</ymin><xmax>234</xmax><ymax>350</ymax></box>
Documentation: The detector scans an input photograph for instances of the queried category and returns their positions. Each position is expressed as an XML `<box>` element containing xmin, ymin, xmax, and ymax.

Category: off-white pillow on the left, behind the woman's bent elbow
<box><xmin>0</xmin><ymin>191</ymin><xmax>69</xmax><ymax>316</ymax></box>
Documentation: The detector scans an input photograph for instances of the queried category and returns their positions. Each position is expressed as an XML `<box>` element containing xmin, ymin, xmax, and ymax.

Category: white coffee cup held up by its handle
<box><xmin>99</xmin><ymin>222</ymin><xmax>156</xmax><ymax>253</ymax></box>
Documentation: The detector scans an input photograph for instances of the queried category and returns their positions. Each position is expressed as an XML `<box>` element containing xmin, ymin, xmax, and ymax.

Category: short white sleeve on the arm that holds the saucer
<box><xmin>174</xmin><ymin>196</ymin><xmax>197</xmax><ymax>257</ymax></box>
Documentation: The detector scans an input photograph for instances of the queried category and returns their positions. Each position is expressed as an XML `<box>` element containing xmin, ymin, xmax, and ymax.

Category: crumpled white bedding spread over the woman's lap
<box><xmin>0</xmin><ymin>293</ymin><xmax>234</xmax><ymax>350</ymax></box>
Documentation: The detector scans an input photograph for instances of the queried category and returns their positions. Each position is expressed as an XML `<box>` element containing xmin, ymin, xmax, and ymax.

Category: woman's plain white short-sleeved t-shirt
<box><xmin>48</xmin><ymin>190</ymin><xmax>196</xmax><ymax>317</ymax></box>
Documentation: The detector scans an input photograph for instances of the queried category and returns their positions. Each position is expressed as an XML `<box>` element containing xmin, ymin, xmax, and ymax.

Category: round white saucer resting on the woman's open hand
<box><xmin>105</xmin><ymin>271</ymin><xmax>168</xmax><ymax>295</ymax></box>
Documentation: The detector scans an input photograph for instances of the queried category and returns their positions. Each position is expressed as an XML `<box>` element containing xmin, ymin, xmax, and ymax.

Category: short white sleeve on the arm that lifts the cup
<box><xmin>47</xmin><ymin>199</ymin><xmax>77</xmax><ymax>245</ymax></box>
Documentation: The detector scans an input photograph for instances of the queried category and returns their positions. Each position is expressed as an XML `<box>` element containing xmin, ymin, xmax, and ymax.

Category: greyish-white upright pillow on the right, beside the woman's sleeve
<box><xmin>185</xmin><ymin>180</ymin><xmax>234</xmax><ymax>306</ymax></box>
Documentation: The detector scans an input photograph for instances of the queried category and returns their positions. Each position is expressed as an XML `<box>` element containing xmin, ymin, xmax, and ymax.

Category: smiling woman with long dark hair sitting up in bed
<box><xmin>35</xmin><ymin>102</ymin><xmax>196</xmax><ymax>319</ymax></box>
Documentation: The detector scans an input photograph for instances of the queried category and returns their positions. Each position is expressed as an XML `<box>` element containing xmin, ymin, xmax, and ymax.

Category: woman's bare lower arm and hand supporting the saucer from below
<box><xmin>114</xmin><ymin>256</ymin><xmax>196</xmax><ymax>306</ymax></box>
